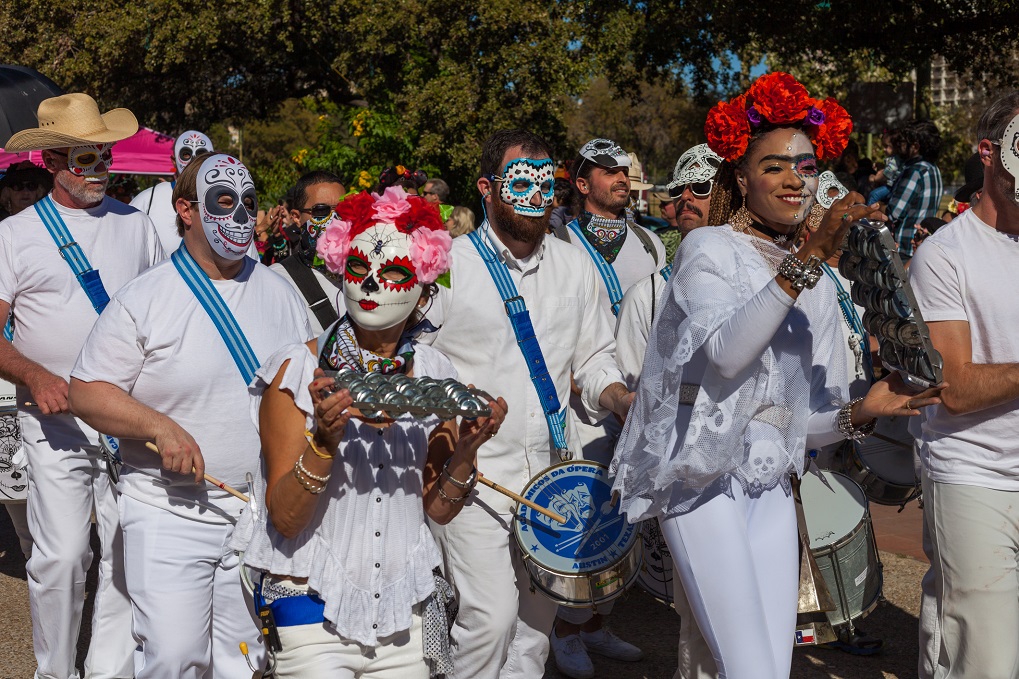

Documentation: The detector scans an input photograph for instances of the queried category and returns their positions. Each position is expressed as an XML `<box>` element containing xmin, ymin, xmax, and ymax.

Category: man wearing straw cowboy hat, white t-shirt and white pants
<box><xmin>0</xmin><ymin>94</ymin><xmax>164</xmax><ymax>679</ymax></box>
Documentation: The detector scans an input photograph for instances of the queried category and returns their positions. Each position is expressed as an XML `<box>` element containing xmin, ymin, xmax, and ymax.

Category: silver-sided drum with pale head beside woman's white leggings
<box><xmin>800</xmin><ymin>471</ymin><xmax>881</xmax><ymax>629</ymax></box>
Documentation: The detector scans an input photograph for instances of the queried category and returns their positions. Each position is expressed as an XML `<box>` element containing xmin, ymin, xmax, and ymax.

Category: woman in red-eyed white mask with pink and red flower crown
<box><xmin>235</xmin><ymin>187</ymin><xmax>506</xmax><ymax>679</ymax></box>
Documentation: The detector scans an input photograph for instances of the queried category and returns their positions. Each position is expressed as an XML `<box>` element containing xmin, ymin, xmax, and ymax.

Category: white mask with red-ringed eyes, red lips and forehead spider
<box><xmin>343</xmin><ymin>223</ymin><xmax>424</xmax><ymax>330</ymax></box>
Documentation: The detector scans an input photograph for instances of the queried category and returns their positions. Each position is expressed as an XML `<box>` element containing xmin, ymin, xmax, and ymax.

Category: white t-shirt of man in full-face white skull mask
<box><xmin>71</xmin><ymin>258</ymin><xmax>311</xmax><ymax>523</ymax></box>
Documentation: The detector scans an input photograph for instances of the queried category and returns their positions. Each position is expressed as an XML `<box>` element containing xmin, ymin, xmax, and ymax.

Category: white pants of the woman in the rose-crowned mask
<box><xmin>273</xmin><ymin>606</ymin><xmax>430</xmax><ymax>679</ymax></box>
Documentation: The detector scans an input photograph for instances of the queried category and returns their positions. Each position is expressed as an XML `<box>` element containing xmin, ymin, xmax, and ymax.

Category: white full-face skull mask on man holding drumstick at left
<box><xmin>197</xmin><ymin>153</ymin><xmax>258</xmax><ymax>260</ymax></box>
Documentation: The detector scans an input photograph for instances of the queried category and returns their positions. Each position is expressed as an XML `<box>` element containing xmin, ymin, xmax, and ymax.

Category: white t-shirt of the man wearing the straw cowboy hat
<box><xmin>0</xmin><ymin>192</ymin><xmax>164</xmax><ymax>412</ymax></box>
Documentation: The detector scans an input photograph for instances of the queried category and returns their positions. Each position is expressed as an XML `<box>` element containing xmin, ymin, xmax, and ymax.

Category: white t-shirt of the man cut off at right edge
<box><xmin>909</xmin><ymin>210</ymin><xmax>1019</xmax><ymax>490</ymax></box>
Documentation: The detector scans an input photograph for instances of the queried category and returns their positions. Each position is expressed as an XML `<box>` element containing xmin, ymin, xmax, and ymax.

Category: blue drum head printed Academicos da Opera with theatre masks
<box><xmin>514</xmin><ymin>461</ymin><xmax>638</xmax><ymax>575</ymax></box>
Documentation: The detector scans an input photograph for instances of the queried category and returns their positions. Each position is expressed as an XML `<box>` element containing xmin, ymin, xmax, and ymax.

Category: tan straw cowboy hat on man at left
<box><xmin>4</xmin><ymin>93</ymin><xmax>138</xmax><ymax>153</ymax></box>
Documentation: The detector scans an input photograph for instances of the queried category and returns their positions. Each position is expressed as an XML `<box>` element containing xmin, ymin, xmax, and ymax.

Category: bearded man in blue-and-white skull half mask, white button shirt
<box><xmin>425</xmin><ymin>129</ymin><xmax>632</xmax><ymax>679</ymax></box>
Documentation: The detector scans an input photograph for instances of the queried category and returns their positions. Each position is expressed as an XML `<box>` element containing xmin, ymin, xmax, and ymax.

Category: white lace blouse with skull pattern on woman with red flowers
<box><xmin>613</xmin><ymin>225</ymin><xmax>848</xmax><ymax>522</ymax></box>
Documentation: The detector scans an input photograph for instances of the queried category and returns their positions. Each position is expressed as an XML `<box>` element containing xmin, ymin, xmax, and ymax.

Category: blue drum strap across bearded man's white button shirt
<box><xmin>468</xmin><ymin>222</ymin><xmax>570</xmax><ymax>461</ymax></box>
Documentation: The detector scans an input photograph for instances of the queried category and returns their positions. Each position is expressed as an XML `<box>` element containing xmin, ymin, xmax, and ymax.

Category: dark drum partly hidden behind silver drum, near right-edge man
<box><xmin>839</xmin><ymin>417</ymin><xmax>920</xmax><ymax>505</ymax></box>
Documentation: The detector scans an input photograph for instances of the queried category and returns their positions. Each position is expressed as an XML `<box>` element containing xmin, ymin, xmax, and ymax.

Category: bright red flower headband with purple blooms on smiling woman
<box><xmin>704</xmin><ymin>72</ymin><xmax>853</xmax><ymax>162</ymax></box>
